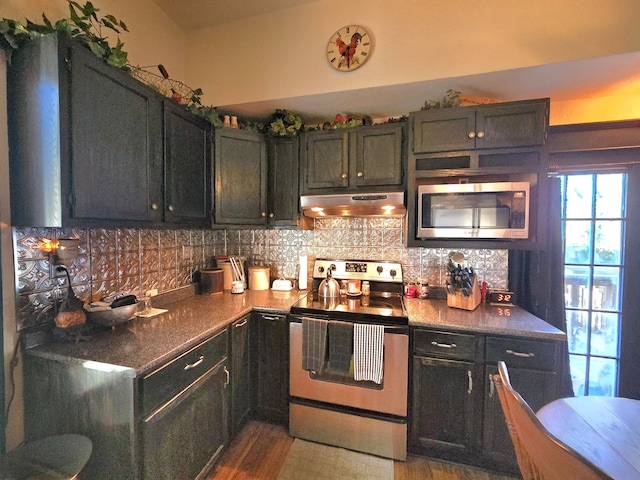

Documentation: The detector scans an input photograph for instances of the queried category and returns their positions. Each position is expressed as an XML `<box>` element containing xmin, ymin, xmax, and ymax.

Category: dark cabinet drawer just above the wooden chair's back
<box><xmin>486</xmin><ymin>337</ymin><xmax>557</xmax><ymax>370</ymax></box>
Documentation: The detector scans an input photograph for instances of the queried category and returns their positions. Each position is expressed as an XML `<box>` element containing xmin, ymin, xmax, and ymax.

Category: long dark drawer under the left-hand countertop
<box><xmin>140</xmin><ymin>330</ymin><xmax>227</xmax><ymax>415</ymax></box>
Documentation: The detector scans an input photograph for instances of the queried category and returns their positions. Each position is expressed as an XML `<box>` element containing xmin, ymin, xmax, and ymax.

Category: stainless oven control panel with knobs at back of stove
<box><xmin>313</xmin><ymin>258</ymin><xmax>402</xmax><ymax>283</ymax></box>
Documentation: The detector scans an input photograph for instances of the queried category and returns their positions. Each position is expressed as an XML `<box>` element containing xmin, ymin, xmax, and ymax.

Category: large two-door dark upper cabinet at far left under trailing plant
<box><xmin>7</xmin><ymin>35</ymin><xmax>210</xmax><ymax>227</ymax></box>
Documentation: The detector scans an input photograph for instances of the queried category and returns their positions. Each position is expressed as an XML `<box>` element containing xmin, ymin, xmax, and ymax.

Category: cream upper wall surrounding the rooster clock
<box><xmin>186</xmin><ymin>0</ymin><xmax>640</xmax><ymax>117</ymax></box>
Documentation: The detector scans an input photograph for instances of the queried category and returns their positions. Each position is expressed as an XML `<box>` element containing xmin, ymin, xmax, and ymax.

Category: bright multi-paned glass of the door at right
<box><xmin>562</xmin><ymin>173</ymin><xmax>627</xmax><ymax>396</ymax></box>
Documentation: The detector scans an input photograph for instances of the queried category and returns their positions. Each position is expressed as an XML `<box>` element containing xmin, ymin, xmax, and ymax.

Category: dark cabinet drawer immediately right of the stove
<box><xmin>413</xmin><ymin>330</ymin><xmax>476</xmax><ymax>360</ymax></box>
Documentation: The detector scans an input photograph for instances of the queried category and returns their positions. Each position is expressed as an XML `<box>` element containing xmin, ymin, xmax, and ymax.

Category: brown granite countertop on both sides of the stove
<box><xmin>26</xmin><ymin>290</ymin><xmax>565</xmax><ymax>377</ymax></box>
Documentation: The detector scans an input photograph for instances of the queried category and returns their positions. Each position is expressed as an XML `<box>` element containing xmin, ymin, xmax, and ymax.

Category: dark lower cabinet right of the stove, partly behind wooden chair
<box><xmin>409</xmin><ymin>329</ymin><xmax>559</xmax><ymax>474</ymax></box>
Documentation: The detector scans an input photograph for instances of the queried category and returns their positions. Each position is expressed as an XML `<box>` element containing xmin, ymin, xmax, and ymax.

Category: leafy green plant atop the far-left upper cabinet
<box><xmin>0</xmin><ymin>0</ymin><xmax>129</xmax><ymax>68</ymax></box>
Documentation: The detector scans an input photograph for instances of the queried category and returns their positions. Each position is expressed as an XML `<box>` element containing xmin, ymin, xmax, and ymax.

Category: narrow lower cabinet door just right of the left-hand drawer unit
<box><xmin>230</xmin><ymin>315</ymin><xmax>254</xmax><ymax>436</ymax></box>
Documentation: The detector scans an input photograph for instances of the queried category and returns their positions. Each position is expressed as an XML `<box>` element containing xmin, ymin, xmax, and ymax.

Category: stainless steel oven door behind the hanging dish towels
<box><xmin>289</xmin><ymin>321</ymin><xmax>409</xmax><ymax>417</ymax></box>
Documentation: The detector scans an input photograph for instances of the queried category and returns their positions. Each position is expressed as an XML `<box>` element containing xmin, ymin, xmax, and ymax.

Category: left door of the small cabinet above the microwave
<box><xmin>411</xmin><ymin>107</ymin><xmax>476</xmax><ymax>153</ymax></box>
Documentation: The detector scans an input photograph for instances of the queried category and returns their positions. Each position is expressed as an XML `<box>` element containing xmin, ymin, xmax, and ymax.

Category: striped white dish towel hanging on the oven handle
<box><xmin>353</xmin><ymin>323</ymin><xmax>384</xmax><ymax>384</ymax></box>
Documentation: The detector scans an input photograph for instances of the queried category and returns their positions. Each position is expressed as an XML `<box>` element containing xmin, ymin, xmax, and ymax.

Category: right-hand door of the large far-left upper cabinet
<box><xmin>164</xmin><ymin>101</ymin><xmax>211</xmax><ymax>227</ymax></box>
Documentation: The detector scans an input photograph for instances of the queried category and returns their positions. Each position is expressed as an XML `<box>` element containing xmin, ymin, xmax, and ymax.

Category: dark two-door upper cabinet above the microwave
<box><xmin>412</xmin><ymin>99</ymin><xmax>549</xmax><ymax>153</ymax></box>
